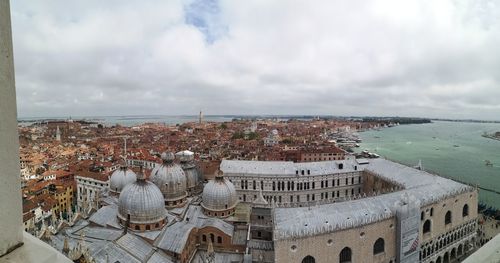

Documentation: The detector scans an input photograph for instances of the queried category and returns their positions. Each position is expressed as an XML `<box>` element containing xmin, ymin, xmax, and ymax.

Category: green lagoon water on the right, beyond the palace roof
<box><xmin>359</xmin><ymin>122</ymin><xmax>500</xmax><ymax>208</ymax></box>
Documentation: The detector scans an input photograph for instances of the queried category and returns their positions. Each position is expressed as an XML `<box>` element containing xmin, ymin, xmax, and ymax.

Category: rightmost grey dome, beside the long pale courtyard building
<box><xmin>201</xmin><ymin>176</ymin><xmax>238</xmax><ymax>217</ymax></box>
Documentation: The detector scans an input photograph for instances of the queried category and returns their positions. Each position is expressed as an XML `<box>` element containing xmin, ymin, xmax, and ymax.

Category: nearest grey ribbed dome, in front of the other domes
<box><xmin>118</xmin><ymin>179</ymin><xmax>167</xmax><ymax>230</ymax></box>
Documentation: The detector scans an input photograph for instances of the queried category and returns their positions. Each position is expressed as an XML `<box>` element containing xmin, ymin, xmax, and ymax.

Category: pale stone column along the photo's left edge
<box><xmin>0</xmin><ymin>0</ymin><xmax>23</xmax><ymax>256</ymax></box>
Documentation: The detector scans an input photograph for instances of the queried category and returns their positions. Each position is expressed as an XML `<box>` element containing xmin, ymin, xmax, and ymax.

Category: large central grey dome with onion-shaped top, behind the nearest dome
<box><xmin>150</xmin><ymin>153</ymin><xmax>187</xmax><ymax>207</ymax></box>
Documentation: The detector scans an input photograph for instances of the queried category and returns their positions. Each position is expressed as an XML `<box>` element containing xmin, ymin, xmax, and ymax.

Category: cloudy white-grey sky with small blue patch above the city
<box><xmin>11</xmin><ymin>0</ymin><xmax>500</xmax><ymax>120</ymax></box>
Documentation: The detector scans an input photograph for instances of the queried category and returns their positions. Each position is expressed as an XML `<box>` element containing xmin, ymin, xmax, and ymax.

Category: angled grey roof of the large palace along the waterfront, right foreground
<box><xmin>274</xmin><ymin>159</ymin><xmax>473</xmax><ymax>239</ymax></box>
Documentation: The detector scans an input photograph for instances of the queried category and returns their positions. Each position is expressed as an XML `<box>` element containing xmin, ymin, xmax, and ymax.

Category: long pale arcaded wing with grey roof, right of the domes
<box><xmin>221</xmin><ymin>158</ymin><xmax>397</xmax><ymax>206</ymax></box>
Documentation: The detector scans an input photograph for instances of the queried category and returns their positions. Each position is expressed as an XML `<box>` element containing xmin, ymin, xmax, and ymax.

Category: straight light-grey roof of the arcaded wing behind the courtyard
<box><xmin>220</xmin><ymin>159</ymin><xmax>358</xmax><ymax>176</ymax></box>
